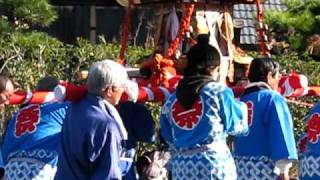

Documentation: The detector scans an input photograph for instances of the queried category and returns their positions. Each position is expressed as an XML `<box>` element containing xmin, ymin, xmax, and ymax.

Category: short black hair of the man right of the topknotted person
<box><xmin>248</xmin><ymin>58</ymin><xmax>280</xmax><ymax>82</ymax></box>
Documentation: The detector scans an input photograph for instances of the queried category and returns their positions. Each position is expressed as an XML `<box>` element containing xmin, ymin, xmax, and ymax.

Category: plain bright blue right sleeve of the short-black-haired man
<box><xmin>266</xmin><ymin>95</ymin><xmax>297</xmax><ymax>161</ymax></box>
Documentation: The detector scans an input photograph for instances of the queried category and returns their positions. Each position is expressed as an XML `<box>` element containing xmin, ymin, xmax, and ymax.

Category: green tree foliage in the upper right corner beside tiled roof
<box><xmin>265</xmin><ymin>0</ymin><xmax>320</xmax><ymax>51</ymax></box>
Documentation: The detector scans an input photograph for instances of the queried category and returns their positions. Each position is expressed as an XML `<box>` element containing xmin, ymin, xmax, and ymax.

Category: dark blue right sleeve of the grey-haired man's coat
<box><xmin>88</xmin><ymin>117</ymin><xmax>122</xmax><ymax>180</ymax></box>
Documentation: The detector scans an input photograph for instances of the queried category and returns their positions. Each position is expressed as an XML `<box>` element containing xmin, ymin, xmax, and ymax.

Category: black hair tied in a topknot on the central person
<box><xmin>184</xmin><ymin>34</ymin><xmax>220</xmax><ymax>76</ymax></box>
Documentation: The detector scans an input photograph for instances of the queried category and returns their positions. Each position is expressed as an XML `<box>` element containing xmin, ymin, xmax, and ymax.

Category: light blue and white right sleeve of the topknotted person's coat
<box><xmin>220</xmin><ymin>88</ymin><xmax>248</xmax><ymax>135</ymax></box>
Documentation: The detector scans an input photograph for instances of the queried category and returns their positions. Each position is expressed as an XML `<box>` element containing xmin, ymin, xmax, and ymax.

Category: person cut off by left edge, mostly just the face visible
<box><xmin>0</xmin><ymin>75</ymin><xmax>14</xmax><ymax>179</ymax></box>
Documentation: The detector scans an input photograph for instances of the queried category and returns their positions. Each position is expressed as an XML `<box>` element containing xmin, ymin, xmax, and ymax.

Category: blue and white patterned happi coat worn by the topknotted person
<box><xmin>160</xmin><ymin>82</ymin><xmax>248</xmax><ymax>180</ymax></box>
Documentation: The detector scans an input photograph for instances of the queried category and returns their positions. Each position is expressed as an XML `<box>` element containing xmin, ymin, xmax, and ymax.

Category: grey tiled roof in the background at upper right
<box><xmin>233</xmin><ymin>0</ymin><xmax>287</xmax><ymax>44</ymax></box>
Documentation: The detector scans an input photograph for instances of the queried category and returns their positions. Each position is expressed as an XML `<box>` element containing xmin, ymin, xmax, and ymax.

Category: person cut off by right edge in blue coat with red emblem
<box><xmin>299</xmin><ymin>103</ymin><xmax>320</xmax><ymax>180</ymax></box>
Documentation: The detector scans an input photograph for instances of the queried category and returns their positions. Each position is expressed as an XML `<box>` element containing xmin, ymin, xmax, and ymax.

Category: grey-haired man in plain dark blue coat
<box><xmin>55</xmin><ymin>60</ymin><xmax>128</xmax><ymax>180</ymax></box>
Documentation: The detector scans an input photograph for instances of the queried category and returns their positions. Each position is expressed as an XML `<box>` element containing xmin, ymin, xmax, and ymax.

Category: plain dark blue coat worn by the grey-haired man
<box><xmin>55</xmin><ymin>94</ymin><xmax>122</xmax><ymax>180</ymax></box>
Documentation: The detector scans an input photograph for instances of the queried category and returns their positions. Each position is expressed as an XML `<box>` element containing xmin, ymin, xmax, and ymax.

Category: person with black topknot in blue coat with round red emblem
<box><xmin>160</xmin><ymin>35</ymin><xmax>248</xmax><ymax>180</ymax></box>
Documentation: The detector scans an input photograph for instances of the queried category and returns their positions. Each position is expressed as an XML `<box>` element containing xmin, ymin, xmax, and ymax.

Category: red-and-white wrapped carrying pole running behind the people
<box><xmin>6</xmin><ymin>73</ymin><xmax>320</xmax><ymax>105</ymax></box>
